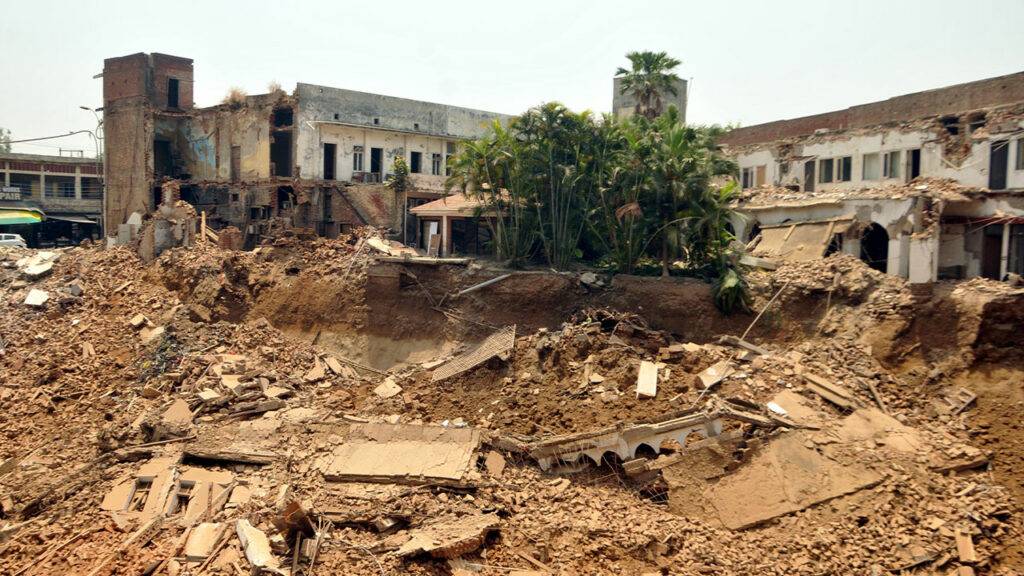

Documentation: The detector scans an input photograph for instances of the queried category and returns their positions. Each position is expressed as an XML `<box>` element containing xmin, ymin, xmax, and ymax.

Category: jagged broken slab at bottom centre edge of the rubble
<box><xmin>395</xmin><ymin>513</ymin><xmax>501</xmax><ymax>559</ymax></box>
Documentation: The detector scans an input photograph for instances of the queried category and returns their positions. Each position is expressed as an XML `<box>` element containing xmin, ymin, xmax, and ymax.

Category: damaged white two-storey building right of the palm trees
<box><xmin>721</xmin><ymin>73</ymin><xmax>1024</xmax><ymax>284</ymax></box>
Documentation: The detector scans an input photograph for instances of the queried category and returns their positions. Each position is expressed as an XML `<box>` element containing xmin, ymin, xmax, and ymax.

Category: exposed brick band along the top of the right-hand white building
<box><xmin>720</xmin><ymin>72</ymin><xmax>1024</xmax><ymax>146</ymax></box>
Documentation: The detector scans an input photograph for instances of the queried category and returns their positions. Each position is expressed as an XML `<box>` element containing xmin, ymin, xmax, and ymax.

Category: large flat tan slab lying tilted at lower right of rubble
<box><xmin>705</xmin><ymin>431</ymin><xmax>884</xmax><ymax>530</ymax></box>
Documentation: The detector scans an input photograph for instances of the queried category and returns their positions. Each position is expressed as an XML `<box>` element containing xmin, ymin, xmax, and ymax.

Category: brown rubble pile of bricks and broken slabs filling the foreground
<box><xmin>0</xmin><ymin>235</ymin><xmax>1021</xmax><ymax>576</ymax></box>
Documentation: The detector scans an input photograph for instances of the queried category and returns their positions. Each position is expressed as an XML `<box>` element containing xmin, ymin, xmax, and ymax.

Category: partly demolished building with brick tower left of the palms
<box><xmin>103</xmin><ymin>53</ymin><xmax>509</xmax><ymax>245</ymax></box>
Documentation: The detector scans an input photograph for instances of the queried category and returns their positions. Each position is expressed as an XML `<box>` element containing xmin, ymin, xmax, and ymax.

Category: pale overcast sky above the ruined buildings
<box><xmin>0</xmin><ymin>0</ymin><xmax>1024</xmax><ymax>154</ymax></box>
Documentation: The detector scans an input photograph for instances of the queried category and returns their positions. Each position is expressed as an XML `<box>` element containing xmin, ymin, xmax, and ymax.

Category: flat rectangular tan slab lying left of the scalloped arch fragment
<box><xmin>324</xmin><ymin>423</ymin><xmax>480</xmax><ymax>484</ymax></box>
